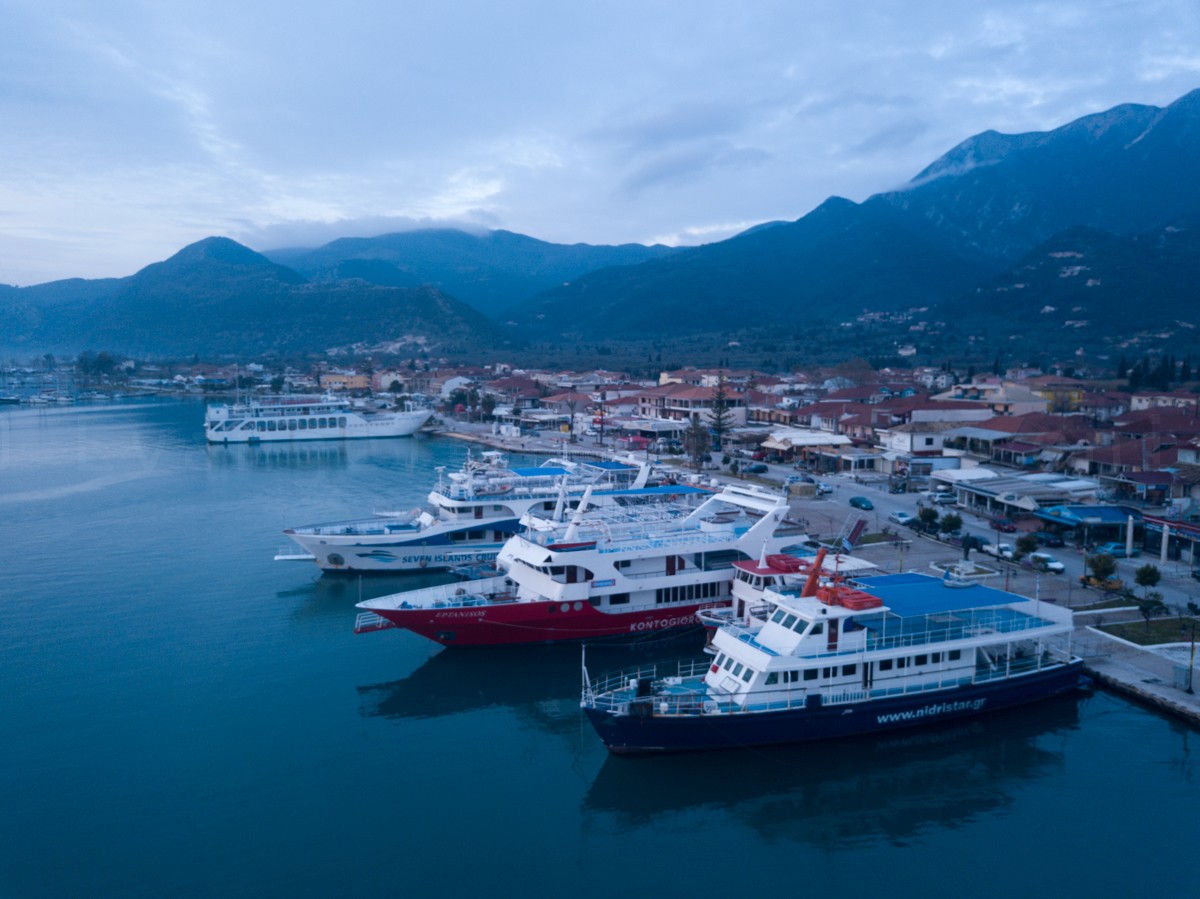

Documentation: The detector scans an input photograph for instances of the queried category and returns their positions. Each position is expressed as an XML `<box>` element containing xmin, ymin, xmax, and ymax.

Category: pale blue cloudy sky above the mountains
<box><xmin>0</xmin><ymin>0</ymin><xmax>1200</xmax><ymax>284</ymax></box>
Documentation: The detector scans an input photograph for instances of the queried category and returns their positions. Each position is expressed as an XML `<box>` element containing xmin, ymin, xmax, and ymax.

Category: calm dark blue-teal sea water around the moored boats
<box><xmin>0</xmin><ymin>403</ymin><xmax>1200</xmax><ymax>898</ymax></box>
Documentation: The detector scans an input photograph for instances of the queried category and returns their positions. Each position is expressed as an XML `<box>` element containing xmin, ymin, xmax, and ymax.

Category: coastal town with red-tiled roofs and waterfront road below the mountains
<box><xmin>4</xmin><ymin>350</ymin><xmax>1200</xmax><ymax>720</ymax></box>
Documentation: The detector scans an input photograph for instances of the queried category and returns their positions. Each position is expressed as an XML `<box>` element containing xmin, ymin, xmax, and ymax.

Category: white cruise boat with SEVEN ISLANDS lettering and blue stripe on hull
<box><xmin>283</xmin><ymin>450</ymin><xmax>676</xmax><ymax>574</ymax></box>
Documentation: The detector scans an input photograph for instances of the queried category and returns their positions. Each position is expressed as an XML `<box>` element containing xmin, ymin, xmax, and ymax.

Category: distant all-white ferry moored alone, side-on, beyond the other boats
<box><xmin>204</xmin><ymin>394</ymin><xmax>433</xmax><ymax>443</ymax></box>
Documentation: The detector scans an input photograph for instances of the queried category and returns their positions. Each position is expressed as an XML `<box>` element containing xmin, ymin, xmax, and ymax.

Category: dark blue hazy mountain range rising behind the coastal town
<box><xmin>0</xmin><ymin>85</ymin><xmax>1200</xmax><ymax>361</ymax></box>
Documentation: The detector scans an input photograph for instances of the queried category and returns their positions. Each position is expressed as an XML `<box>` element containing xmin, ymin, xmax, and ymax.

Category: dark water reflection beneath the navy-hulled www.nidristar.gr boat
<box><xmin>583</xmin><ymin>697</ymin><xmax>1087</xmax><ymax>850</ymax></box>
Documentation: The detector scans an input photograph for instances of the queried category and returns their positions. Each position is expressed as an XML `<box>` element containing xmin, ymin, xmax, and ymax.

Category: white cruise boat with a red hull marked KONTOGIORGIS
<box><xmin>355</xmin><ymin>485</ymin><xmax>806</xmax><ymax>646</ymax></box>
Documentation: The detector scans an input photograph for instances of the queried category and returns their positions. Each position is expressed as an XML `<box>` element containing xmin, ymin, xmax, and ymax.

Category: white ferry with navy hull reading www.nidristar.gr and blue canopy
<box><xmin>581</xmin><ymin>554</ymin><xmax>1087</xmax><ymax>754</ymax></box>
